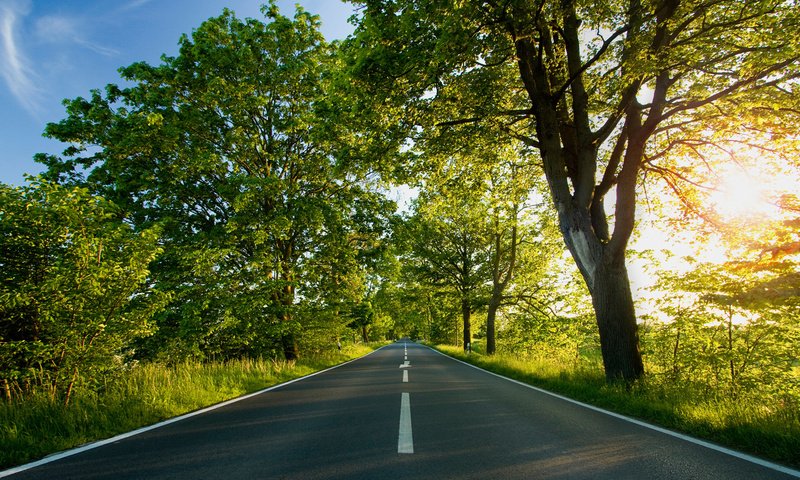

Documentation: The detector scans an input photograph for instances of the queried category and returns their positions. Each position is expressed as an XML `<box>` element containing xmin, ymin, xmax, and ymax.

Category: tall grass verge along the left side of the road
<box><xmin>0</xmin><ymin>345</ymin><xmax>379</xmax><ymax>469</ymax></box>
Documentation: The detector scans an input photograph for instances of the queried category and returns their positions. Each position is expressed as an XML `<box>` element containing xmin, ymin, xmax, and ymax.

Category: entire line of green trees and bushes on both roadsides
<box><xmin>0</xmin><ymin>0</ymin><xmax>800</xmax><ymax>402</ymax></box>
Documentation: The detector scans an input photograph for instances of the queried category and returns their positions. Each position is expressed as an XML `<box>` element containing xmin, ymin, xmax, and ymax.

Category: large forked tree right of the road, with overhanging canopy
<box><xmin>351</xmin><ymin>0</ymin><xmax>800</xmax><ymax>381</ymax></box>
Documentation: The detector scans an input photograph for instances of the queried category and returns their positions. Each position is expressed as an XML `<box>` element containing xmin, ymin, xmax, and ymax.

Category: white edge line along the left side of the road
<box><xmin>0</xmin><ymin>345</ymin><xmax>388</xmax><ymax>478</ymax></box>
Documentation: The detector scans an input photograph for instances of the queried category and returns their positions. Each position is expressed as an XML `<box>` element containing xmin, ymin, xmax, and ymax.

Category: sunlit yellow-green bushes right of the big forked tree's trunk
<box><xmin>646</xmin><ymin>262</ymin><xmax>800</xmax><ymax>403</ymax></box>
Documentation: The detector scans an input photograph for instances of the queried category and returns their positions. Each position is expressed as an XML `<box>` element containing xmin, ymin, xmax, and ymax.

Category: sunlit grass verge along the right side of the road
<box><xmin>435</xmin><ymin>345</ymin><xmax>800</xmax><ymax>468</ymax></box>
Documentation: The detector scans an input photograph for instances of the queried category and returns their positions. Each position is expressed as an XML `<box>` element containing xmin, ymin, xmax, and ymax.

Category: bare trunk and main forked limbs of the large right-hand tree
<box><xmin>510</xmin><ymin>26</ymin><xmax>652</xmax><ymax>382</ymax></box>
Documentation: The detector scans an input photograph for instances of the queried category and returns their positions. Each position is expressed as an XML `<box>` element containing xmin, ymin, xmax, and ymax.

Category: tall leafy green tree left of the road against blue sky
<box><xmin>39</xmin><ymin>2</ymin><xmax>391</xmax><ymax>359</ymax></box>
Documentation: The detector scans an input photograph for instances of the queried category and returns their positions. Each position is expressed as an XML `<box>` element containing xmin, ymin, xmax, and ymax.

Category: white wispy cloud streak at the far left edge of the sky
<box><xmin>0</xmin><ymin>0</ymin><xmax>42</xmax><ymax>115</ymax></box>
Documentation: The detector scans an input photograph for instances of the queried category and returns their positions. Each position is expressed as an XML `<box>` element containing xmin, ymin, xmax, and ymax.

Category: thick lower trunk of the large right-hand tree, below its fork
<box><xmin>592</xmin><ymin>262</ymin><xmax>644</xmax><ymax>382</ymax></box>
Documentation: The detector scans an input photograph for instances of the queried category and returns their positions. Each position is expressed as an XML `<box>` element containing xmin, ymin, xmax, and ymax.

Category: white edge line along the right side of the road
<box><xmin>423</xmin><ymin>345</ymin><xmax>800</xmax><ymax>478</ymax></box>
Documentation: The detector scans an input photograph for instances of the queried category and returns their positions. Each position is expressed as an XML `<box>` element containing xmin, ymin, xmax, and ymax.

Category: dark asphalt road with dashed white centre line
<box><xmin>0</xmin><ymin>342</ymin><xmax>800</xmax><ymax>480</ymax></box>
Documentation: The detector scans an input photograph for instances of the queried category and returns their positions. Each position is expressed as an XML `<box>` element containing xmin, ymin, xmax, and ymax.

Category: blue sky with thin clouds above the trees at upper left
<box><xmin>0</xmin><ymin>0</ymin><xmax>353</xmax><ymax>185</ymax></box>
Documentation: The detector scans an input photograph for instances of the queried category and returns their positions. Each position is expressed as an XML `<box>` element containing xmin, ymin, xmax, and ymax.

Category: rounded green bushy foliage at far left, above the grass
<box><xmin>0</xmin><ymin>180</ymin><xmax>166</xmax><ymax>403</ymax></box>
